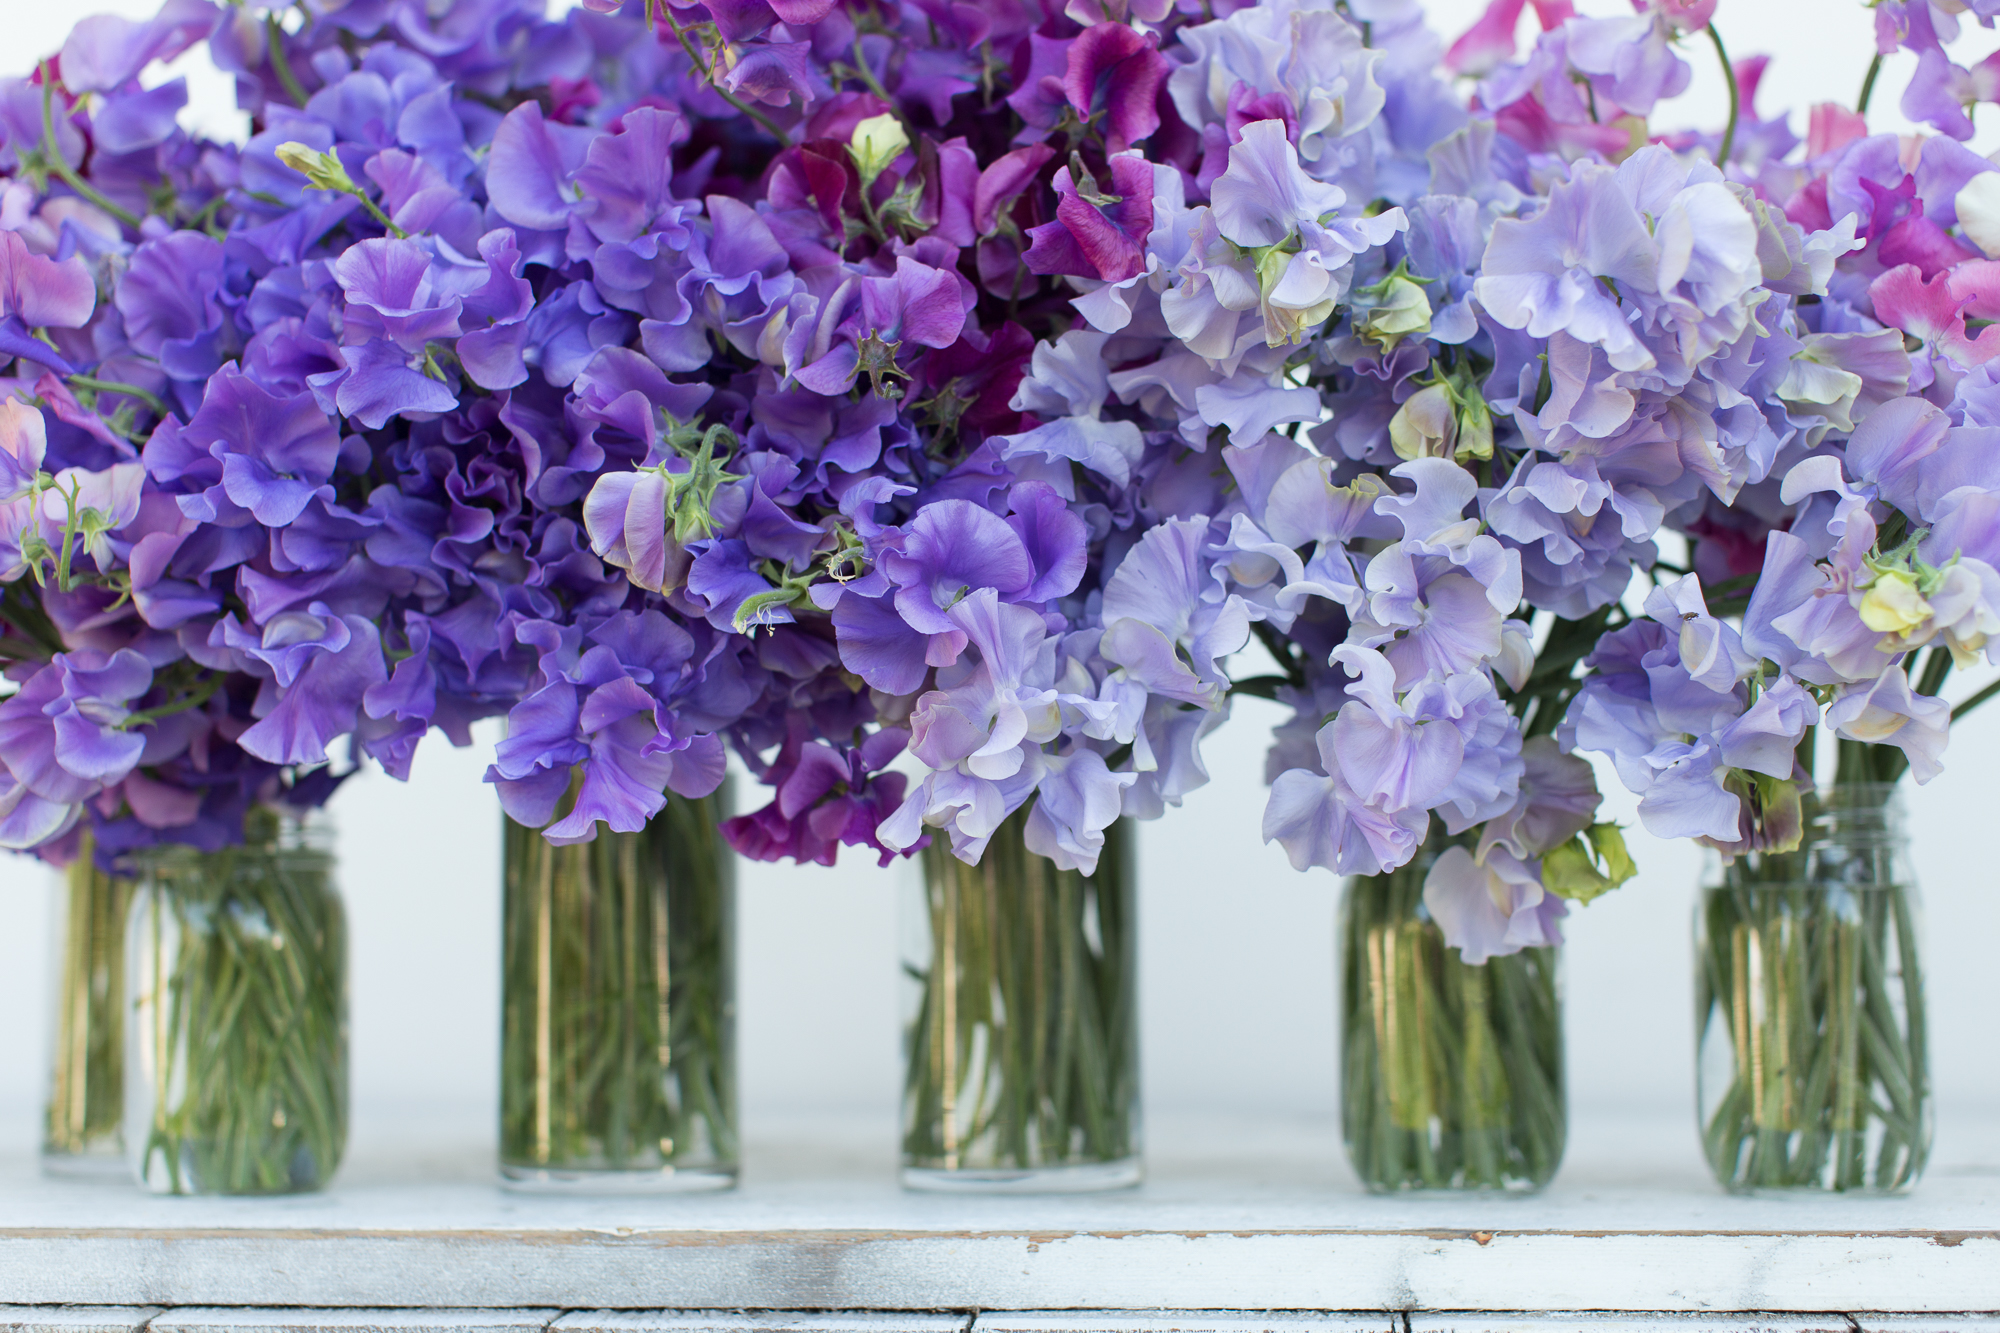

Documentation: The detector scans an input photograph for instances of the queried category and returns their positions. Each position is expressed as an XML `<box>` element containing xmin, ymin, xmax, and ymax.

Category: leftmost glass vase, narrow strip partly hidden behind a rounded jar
<box><xmin>42</xmin><ymin>831</ymin><xmax>132</xmax><ymax>1179</ymax></box>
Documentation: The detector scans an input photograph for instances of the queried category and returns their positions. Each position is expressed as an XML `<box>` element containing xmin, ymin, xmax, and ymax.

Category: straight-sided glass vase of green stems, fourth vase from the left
<box><xmin>902</xmin><ymin>813</ymin><xmax>1140</xmax><ymax>1193</ymax></box>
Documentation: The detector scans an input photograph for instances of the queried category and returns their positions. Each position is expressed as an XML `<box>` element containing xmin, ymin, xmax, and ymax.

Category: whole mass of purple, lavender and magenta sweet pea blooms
<box><xmin>0</xmin><ymin>0</ymin><xmax>2000</xmax><ymax>961</ymax></box>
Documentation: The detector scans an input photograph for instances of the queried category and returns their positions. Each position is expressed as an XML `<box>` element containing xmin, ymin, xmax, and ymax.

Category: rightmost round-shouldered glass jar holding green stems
<box><xmin>1696</xmin><ymin>783</ymin><xmax>1932</xmax><ymax>1193</ymax></box>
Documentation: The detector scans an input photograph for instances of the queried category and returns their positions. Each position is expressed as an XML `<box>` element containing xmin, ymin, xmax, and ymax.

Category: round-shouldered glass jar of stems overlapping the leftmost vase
<box><xmin>124</xmin><ymin>807</ymin><xmax>348</xmax><ymax>1195</ymax></box>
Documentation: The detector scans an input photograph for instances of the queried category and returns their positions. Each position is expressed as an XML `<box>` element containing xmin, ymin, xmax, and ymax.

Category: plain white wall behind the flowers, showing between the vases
<box><xmin>0</xmin><ymin>0</ymin><xmax>2000</xmax><ymax>1171</ymax></box>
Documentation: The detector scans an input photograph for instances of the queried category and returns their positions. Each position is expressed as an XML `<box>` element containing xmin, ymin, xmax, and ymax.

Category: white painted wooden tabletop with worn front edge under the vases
<box><xmin>0</xmin><ymin>1117</ymin><xmax>2000</xmax><ymax>1312</ymax></box>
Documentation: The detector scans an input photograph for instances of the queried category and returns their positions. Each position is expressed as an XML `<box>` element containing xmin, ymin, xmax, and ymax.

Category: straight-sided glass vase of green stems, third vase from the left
<box><xmin>500</xmin><ymin>795</ymin><xmax>738</xmax><ymax>1193</ymax></box>
